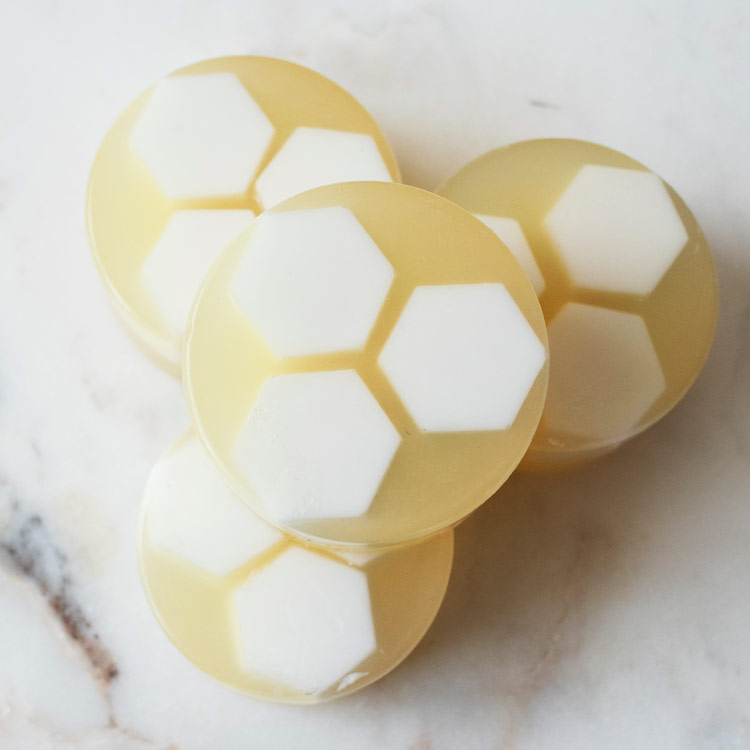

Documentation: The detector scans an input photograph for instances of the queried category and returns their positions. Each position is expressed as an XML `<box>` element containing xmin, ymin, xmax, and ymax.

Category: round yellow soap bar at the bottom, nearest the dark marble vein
<box><xmin>139</xmin><ymin>431</ymin><xmax>453</xmax><ymax>703</ymax></box>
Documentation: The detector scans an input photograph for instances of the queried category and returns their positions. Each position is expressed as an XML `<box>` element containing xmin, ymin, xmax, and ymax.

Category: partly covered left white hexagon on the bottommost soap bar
<box><xmin>145</xmin><ymin>436</ymin><xmax>284</xmax><ymax>576</ymax></box>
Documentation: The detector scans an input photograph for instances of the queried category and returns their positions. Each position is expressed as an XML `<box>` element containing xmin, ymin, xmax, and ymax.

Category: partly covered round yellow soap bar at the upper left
<box><xmin>87</xmin><ymin>57</ymin><xmax>399</xmax><ymax>374</ymax></box>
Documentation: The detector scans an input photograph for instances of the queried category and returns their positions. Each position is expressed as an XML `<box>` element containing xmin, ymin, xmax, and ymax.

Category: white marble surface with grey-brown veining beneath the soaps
<box><xmin>0</xmin><ymin>0</ymin><xmax>750</xmax><ymax>750</ymax></box>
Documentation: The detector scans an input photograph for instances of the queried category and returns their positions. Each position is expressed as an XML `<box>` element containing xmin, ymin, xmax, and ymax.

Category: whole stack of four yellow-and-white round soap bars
<box><xmin>87</xmin><ymin>57</ymin><xmax>717</xmax><ymax>703</ymax></box>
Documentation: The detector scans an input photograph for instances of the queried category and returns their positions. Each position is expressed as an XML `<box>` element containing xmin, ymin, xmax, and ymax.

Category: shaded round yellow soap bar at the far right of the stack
<box><xmin>438</xmin><ymin>139</ymin><xmax>718</xmax><ymax>469</ymax></box>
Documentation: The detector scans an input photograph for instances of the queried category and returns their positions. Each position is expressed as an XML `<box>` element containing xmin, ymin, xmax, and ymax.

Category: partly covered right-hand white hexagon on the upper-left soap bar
<box><xmin>255</xmin><ymin>128</ymin><xmax>391</xmax><ymax>208</ymax></box>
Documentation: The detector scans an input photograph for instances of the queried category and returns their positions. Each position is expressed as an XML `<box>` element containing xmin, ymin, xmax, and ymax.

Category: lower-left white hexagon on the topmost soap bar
<box><xmin>233</xmin><ymin>370</ymin><xmax>401</xmax><ymax>521</ymax></box>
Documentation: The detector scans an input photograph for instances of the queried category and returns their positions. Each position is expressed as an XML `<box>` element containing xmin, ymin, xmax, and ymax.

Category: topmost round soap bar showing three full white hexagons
<box><xmin>183</xmin><ymin>182</ymin><xmax>547</xmax><ymax>546</ymax></box>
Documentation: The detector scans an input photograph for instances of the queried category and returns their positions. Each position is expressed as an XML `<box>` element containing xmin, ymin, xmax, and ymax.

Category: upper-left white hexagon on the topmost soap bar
<box><xmin>232</xmin><ymin>206</ymin><xmax>393</xmax><ymax>357</ymax></box>
